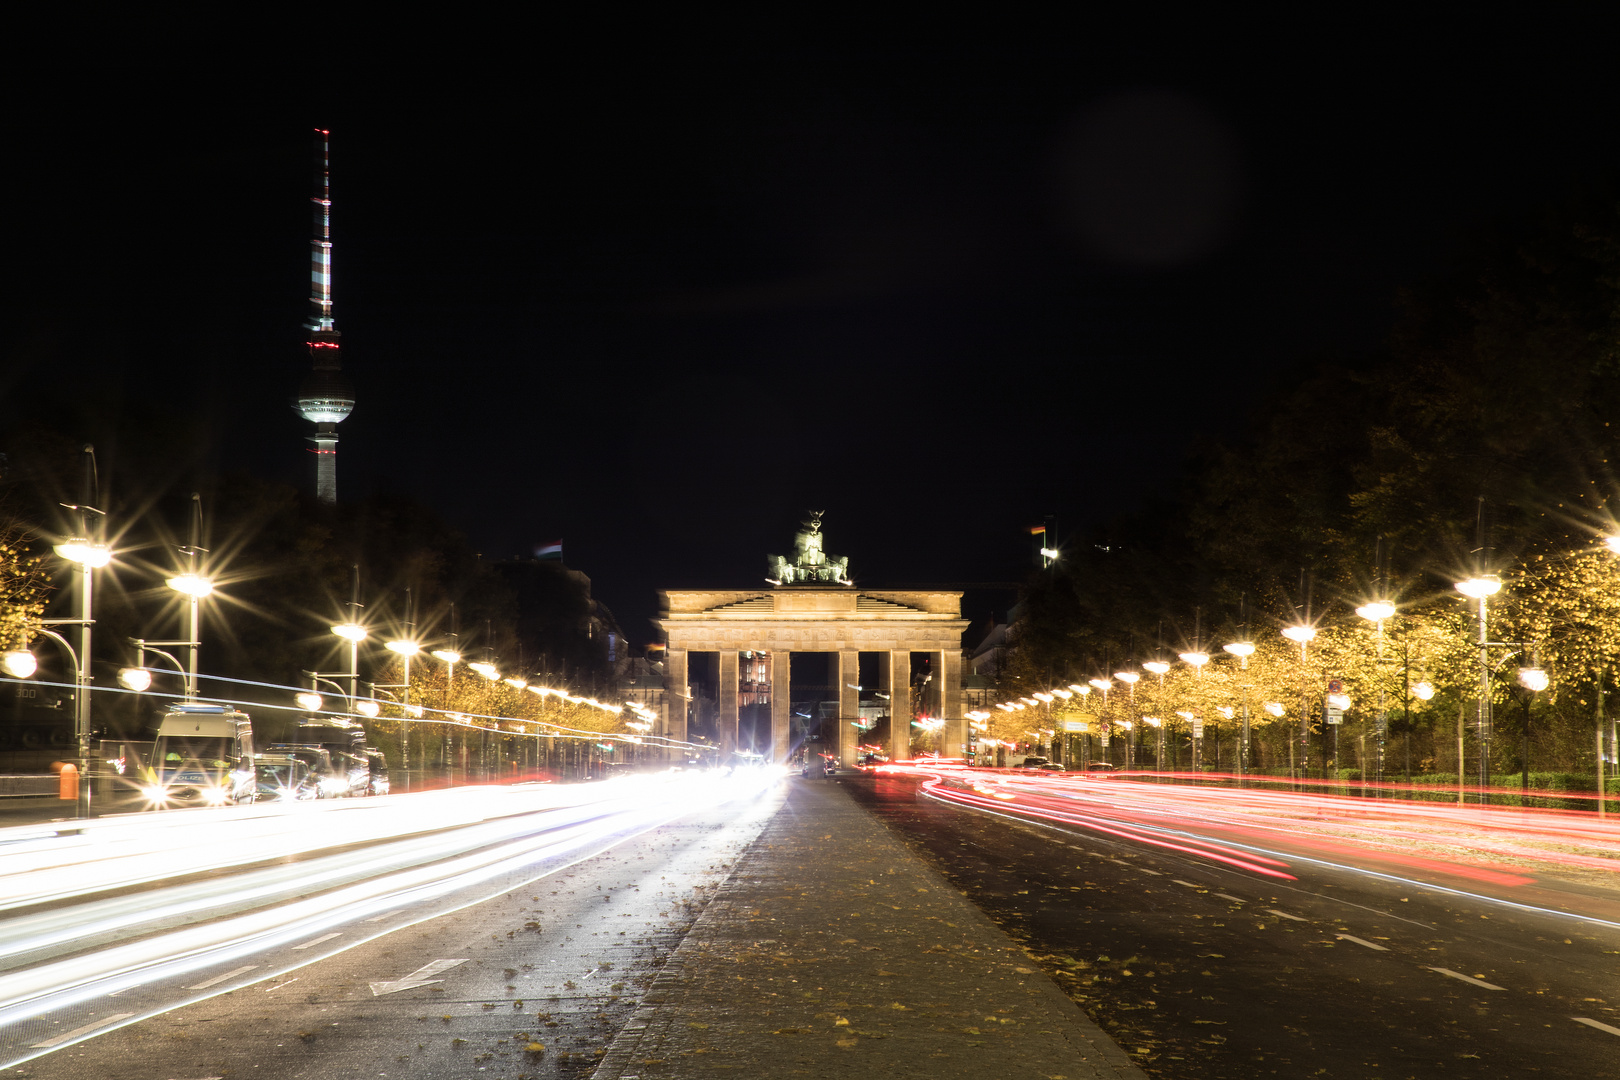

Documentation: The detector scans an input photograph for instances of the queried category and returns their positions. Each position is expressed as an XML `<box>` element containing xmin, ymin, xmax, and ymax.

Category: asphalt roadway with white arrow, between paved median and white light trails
<box><xmin>3</xmin><ymin>793</ymin><xmax>781</xmax><ymax>1080</ymax></box>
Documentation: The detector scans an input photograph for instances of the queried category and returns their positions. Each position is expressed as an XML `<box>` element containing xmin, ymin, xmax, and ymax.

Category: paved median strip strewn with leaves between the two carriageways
<box><xmin>595</xmin><ymin>777</ymin><xmax>1145</xmax><ymax>1080</ymax></box>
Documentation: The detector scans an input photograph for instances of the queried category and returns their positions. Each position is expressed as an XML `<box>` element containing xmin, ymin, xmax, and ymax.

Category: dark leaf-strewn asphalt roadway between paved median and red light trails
<box><xmin>849</xmin><ymin>777</ymin><xmax>1620</xmax><ymax>1080</ymax></box>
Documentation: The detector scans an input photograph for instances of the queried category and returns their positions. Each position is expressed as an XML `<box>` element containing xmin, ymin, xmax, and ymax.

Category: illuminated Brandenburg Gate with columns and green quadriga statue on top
<box><xmin>656</xmin><ymin>513</ymin><xmax>967</xmax><ymax>766</ymax></box>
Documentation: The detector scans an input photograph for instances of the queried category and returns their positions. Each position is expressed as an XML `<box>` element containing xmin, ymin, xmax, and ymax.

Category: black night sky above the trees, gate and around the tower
<box><xmin>0</xmin><ymin>8</ymin><xmax>1620</xmax><ymax>636</ymax></box>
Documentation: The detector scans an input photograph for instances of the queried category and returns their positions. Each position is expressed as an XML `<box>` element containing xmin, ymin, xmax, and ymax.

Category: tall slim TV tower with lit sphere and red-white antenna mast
<box><xmin>293</xmin><ymin>128</ymin><xmax>355</xmax><ymax>502</ymax></box>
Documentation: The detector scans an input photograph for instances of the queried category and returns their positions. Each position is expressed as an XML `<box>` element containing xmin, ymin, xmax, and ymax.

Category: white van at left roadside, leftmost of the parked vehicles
<box><xmin>144</xmin><ymin>703</ymin><xmax>254</xmax><ymax>810</ymax></box>
